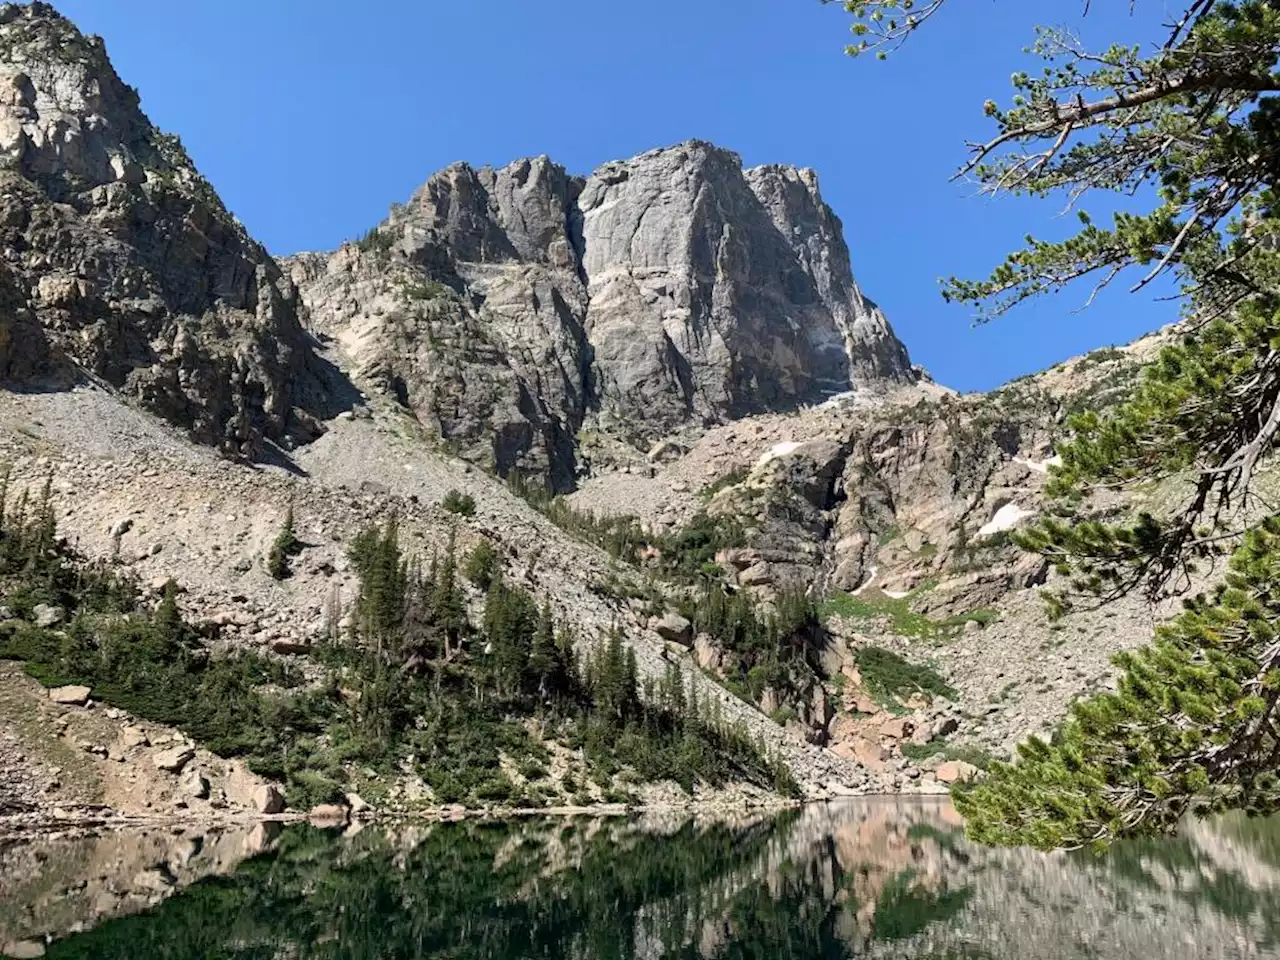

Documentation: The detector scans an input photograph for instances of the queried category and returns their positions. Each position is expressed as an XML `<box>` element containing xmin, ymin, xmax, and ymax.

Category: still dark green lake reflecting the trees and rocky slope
<box><xmin>0</xmin><ymin>800</ymin><xmax>1280</xmax><ymax>960</ymax></box>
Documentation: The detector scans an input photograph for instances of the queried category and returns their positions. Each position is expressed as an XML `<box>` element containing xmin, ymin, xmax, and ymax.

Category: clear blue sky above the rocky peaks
<box><xmin>49</xmin><ymin>0</ymin><xmax>1176</xmax><ymax>390</ymax></box>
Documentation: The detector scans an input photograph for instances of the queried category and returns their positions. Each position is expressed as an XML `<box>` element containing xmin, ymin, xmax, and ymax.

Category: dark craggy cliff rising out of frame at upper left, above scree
<box><xmin>0</xmin><ymin>3</ymin><xmax>321</xmax><ymax>454</ymax></box>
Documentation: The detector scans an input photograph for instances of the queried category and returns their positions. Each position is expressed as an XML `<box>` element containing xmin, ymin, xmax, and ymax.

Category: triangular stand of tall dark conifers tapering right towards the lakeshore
<box><xmin>330</xmin><ymin>522</ymin><xmax>796</xmax><ymax>801</ymax></box>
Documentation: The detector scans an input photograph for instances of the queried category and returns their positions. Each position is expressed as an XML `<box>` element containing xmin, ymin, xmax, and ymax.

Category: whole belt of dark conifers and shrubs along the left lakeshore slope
<box><xmin>0</xmin><ymin>480</ymin><xmax>796</xmax><ymax>806</ymax></box>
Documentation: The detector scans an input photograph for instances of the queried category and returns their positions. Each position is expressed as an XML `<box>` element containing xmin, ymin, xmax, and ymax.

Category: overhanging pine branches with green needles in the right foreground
<box><xmin>847</xmin><ymin>0</ymin><xmax>1280</xmax><ymax>847</ymax></box>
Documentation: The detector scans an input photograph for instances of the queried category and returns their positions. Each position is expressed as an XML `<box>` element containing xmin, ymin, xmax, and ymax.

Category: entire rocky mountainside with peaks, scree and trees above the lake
<box><xmin>0</xmin><ymin>3</ymin><xmax>1166</xmax><ymax>817</ymax></box>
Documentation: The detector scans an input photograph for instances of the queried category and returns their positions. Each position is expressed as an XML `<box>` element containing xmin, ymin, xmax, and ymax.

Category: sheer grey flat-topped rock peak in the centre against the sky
<box><xmin>288</xmin><ymin>141</ymin><xmax>915</xmax><ymax>489</ymax></box>
